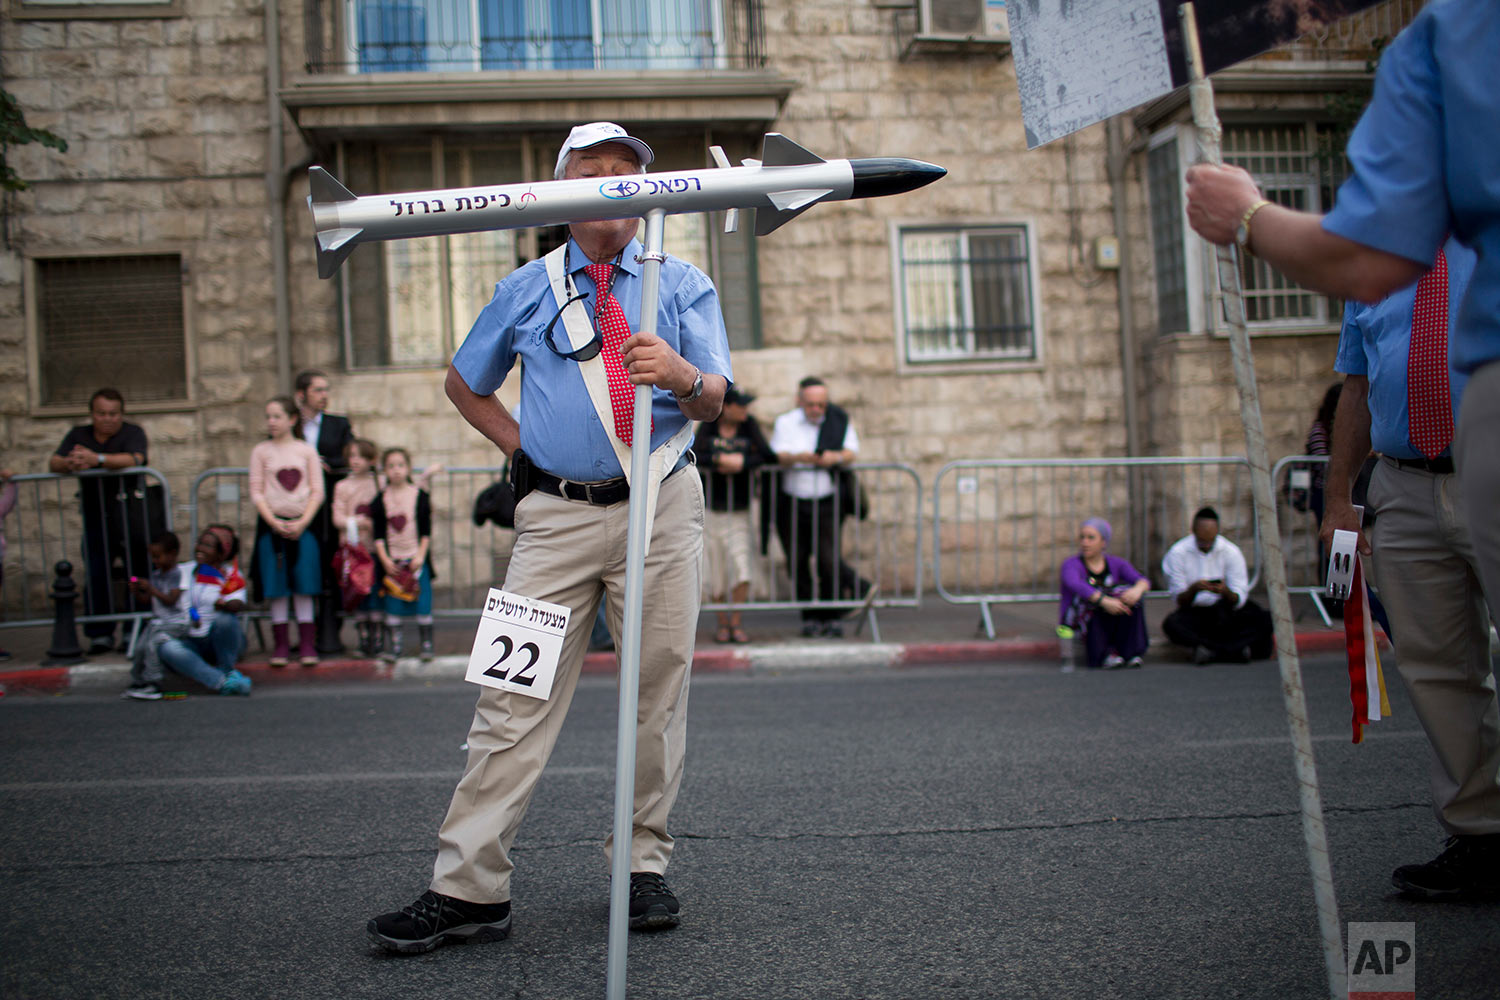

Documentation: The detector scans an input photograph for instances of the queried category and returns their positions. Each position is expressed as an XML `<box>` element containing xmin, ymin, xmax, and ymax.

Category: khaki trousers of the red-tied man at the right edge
<box><xmin>1370</xmin><ymin>459</ymin><xmax>1500</xmax><ymax>834</ymax></box>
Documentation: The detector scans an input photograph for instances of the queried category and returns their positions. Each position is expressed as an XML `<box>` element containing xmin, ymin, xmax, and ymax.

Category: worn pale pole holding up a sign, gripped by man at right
<box><xmin>1178</xmin><ymin>3</ymin><xmax>1349</xmax><ymax>1000</ymax></box>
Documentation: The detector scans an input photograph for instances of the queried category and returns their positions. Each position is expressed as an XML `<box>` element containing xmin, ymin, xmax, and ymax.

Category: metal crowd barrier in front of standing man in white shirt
<box><xmin>702</xmin><ymin>462</ymin><xmax>923</xmax><ymax>642</ymax></box>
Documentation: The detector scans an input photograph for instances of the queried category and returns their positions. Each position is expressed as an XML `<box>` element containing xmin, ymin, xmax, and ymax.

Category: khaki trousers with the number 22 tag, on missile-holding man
<box><xmin>432</xmin><ymin>468</ymin><xmax>704</xmax><ymax>903</ymax></box>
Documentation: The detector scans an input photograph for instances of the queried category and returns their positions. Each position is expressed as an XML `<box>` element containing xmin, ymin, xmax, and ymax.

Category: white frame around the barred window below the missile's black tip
<box><xmin>888</xmin><ymin>216</ymin><xmax>1047</xmax><ymax>375</ymax></box>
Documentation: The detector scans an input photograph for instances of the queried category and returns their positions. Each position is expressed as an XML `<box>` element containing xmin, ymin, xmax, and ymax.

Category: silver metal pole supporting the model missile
<box><xmin>605</xmin><ymin>208</ymin><xmax>666</xmax><ymax>1000</ymax></box>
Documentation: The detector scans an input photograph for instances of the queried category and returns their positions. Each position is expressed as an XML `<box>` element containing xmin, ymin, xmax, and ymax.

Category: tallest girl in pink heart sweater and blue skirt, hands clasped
<box><xmin>251</xmin><ymin>396</ymin><xmax>323</xmax><ymax>667</ymax></box>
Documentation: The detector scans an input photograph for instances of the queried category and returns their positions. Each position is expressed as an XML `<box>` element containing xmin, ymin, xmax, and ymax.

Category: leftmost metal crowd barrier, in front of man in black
<box><xmin>0</xmin><ymin>466</ymin><xmax>174</xmax><ymax>643</ymax></box>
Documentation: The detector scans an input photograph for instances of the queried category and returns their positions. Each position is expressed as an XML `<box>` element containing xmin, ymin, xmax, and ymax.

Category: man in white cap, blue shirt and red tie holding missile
<box><xmin>369</xmin><ymin>121</ymin><xmax>731</xmax><ymax>954</ymax></box>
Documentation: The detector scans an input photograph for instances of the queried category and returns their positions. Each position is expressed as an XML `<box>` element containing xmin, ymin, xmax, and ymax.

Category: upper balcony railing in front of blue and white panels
<box><xmin>306</xmin><ymin>0</ymin><xmax>765</xmax><ymax>73</ymax></box>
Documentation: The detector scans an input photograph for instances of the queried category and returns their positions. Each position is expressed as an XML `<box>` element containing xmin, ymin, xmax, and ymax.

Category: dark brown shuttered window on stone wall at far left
<box><xmin>30</xmin><ymin>253</ymin><xmax>189</xmax><ymax>408</ymax></box>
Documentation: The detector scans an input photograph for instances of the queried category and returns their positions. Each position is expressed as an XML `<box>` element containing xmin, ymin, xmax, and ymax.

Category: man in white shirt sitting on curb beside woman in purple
<box><xmin>1161</xmin><ymin>507</ymin><xmax>1274</xmax><ymax>667</ymax></box>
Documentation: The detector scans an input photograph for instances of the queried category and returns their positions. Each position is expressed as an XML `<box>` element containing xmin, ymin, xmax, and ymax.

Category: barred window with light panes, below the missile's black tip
<box><xmin>897</xmin><ymin>225</ymin><xmax>1037</xmax><ymax>364</ymax></box>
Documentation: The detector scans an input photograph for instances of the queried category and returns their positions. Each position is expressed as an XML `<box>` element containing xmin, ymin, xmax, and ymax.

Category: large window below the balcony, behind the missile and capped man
<box><xmin>339</xmin><ymin>135</ymin><xmax>759</xmax><ymax>369</ymax></box>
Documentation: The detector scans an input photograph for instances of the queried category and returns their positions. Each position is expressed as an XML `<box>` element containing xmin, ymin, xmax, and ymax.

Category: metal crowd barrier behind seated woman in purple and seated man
<box><xmin>932</xmin><ymin>457</ymin><xmax>1260</xmax><ymax>639</ymax></box>
